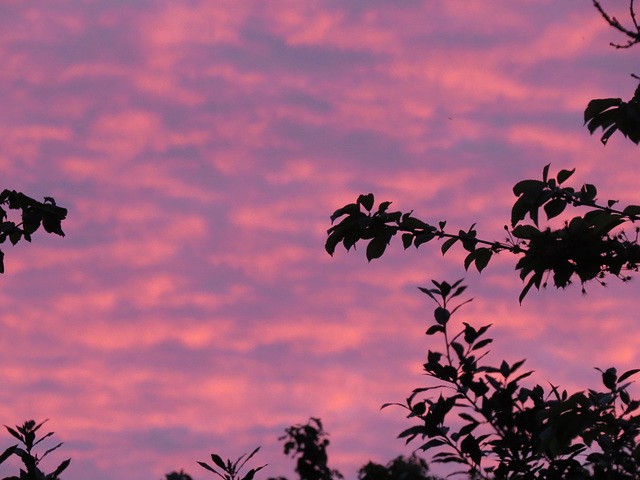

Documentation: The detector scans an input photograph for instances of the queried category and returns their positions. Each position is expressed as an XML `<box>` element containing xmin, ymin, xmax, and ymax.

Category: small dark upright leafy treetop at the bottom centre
<box><xmin>269</xmin><ymin>418</ymin><xmax>343</xmax><ymax>480</ymax></box>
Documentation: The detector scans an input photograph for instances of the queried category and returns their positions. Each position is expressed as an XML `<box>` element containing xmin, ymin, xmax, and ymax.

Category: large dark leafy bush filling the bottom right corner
<box><xmin>383</xmin><ymin>281</ymin><xmax>640</xmax><ymax>480</ymax></box>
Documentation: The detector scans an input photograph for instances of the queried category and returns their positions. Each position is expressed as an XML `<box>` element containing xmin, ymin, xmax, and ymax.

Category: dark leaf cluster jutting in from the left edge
<box><xmin>0</xmin><ymin>189</ymin><xmax>67</xmax><ymax>273</ymax></box>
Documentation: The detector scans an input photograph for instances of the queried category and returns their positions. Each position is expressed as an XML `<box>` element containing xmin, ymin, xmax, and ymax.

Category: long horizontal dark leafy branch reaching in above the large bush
<box><xmin>325</xmin><ymin>165</ymin><xmax>640</xmax><ymax>302</ymax></box>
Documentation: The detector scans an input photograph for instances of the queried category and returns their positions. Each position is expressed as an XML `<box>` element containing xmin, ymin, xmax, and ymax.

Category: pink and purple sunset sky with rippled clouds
<box><xmin>0</xmin><ymin>0</ymin><xmax>640</xmax><ymax>480</ymax></box>
